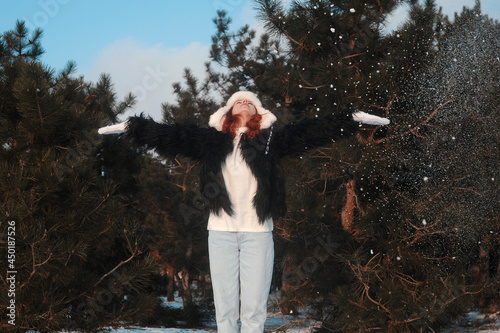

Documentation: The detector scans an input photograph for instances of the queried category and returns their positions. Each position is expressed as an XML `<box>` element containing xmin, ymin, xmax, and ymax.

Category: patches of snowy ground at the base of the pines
<box><xmin>106</xmin><ymin>295</ymin><xmax>500</xmax><ymax>333</ymax></box>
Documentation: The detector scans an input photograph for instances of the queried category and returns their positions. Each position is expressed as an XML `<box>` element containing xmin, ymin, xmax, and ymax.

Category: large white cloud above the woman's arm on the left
<box><xmin>83</xmin><ymin>38</ymin><xmax>209</xmax><ymax>121</ymax></box>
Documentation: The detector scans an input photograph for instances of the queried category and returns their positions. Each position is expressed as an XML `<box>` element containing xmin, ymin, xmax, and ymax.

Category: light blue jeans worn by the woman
<box><xmin>208</xmin><ymin>230</ymin><xmax>274</xmax><ymax>333</ymax></box>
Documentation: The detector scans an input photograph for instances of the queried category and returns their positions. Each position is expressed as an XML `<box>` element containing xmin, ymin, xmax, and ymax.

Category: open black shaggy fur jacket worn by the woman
<box><xmin>125</xmin><ymin>111</ymin><xmax>359</xmax><ymax>223</ymax></box>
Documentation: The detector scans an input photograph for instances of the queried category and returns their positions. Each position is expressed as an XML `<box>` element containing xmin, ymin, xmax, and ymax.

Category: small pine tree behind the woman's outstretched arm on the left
<box><xmin>141</xmin><ymin>69</ymin><xmax>217</xmax><ymax>327</ymax></box>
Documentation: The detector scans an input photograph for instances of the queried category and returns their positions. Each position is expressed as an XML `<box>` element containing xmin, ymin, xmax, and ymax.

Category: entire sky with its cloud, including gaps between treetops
<box><xmin>0</xmin><ymin>0</ymin><xmax>500</xmax><ymax>120</ymax></box>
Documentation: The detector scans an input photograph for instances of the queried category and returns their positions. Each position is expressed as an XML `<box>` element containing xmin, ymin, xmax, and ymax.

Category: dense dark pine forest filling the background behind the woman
<box><xmin>0</xmin><ymin>0</ymin><xmax>500</xmax><ymax>332</ymax></box>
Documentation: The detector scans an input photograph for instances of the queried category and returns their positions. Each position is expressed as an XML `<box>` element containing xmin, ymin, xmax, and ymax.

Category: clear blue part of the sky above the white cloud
<box><xmin>0</xmin><ymin>0</ymin><xmax>249</xmax><ymax>68</ymax></box>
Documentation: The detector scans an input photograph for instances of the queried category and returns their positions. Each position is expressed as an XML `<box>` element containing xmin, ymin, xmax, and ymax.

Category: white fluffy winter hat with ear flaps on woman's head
<box><xmin>208</xmin><ymin>91</ymin><xmax>277</xmax><ymax>131</ymax></box>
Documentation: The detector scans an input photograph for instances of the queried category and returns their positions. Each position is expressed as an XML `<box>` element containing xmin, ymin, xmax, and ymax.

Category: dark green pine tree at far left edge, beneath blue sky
<box><xmin>0</xmin><ymin>22</ymin><xmax>156</xmax><ymax>332</ymax></box>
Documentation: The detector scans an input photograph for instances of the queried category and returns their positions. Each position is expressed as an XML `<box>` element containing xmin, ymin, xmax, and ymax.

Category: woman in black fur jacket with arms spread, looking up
<box><xmin>99</xmin><ymin>91</ymin><xmax>389</xmax><ymax>333</ymax></box>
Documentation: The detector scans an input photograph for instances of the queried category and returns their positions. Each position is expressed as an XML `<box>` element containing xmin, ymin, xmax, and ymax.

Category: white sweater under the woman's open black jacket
<box><xmin>208</xmin><ymin>127</ymin><xmax>273</xmax><ymax>232</ymax></box>
